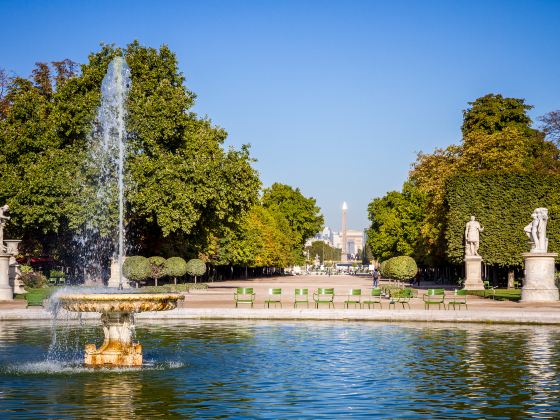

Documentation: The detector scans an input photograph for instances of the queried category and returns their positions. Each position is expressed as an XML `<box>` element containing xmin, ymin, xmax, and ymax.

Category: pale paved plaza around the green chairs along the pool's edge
<box><xmin>0</xmin><ymin>275</ymin><xmax>560</xmax><ymax>325</ymax></box>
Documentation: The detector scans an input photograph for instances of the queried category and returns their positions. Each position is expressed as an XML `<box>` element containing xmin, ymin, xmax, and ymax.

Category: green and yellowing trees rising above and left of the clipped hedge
<box><xmin>368</xmin><ymin>94</ymin><xmax>560</xmax><ymax>265</ymax></box>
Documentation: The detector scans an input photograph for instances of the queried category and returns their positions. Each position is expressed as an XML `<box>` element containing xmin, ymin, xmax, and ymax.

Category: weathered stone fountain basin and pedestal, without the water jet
<box><xmin>58</xmin><ymin>293</ymin><xmax>185</xmax><ymax>367</ymax></box>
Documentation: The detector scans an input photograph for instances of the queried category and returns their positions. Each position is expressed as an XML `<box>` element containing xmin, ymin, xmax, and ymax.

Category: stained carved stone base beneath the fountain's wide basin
<box><xmin>84</xmin><ymin>312</ymin><xmax>142</xmax><ymax>367</ymax></box>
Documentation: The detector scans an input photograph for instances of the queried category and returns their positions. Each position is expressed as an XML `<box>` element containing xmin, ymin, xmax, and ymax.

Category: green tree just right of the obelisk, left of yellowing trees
<box><xmin>368</xmin><ymin>183</ymin><xmax>425</xmax><ymax>260</ymax></box>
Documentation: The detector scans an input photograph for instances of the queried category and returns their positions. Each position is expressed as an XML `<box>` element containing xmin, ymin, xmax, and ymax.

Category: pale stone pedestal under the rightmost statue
<box><xmin>521</xmin><ymin>252</ymin><xmax>559</xmax><ymax>302</ymax></box>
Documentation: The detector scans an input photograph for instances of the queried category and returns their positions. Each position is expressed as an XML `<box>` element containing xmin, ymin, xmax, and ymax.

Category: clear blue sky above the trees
<box><xmin>0</xmin><ymin>0</ymin><xmax>560</xmax><ymax>230</ymax></box>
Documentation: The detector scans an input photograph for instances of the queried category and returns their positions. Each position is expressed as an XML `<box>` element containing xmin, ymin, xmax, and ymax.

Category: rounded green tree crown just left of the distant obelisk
<box><xmin>262</xmin><ymin>183</ymin><xmax>324</xmax><ymax>254</ymax></box>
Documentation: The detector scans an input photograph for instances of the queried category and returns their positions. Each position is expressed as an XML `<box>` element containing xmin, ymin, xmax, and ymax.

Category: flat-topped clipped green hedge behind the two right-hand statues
<box><xmin>445</xmin><ymin>172</ymin><xmax>560</xmax><ymax>267</ymax></box>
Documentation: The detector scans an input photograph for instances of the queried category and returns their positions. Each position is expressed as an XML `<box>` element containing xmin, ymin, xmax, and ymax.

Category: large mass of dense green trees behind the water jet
<box><xmin>0</xmin><ymin>42</ymin><xmax>260</xmax><ymax>263</ymax></box>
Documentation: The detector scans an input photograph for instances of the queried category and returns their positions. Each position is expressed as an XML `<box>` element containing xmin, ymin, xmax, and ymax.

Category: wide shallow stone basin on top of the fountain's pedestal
<box><xmin>58</xmin><ymin>293</ymin><xmax>185</xmax><ymax>313</ymax></box>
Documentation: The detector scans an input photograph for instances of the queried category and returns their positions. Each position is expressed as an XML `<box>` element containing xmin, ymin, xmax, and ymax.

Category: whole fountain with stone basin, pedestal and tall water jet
<box><xmin>52</xmin><ymin>57</ymin><xmax>184</xmax><ymax>367</ymax></box>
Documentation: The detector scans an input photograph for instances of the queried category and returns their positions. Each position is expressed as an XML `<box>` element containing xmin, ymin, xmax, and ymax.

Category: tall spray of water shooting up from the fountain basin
<box><xmin>78</xmin><ymin>57</ymin><xmax>131</xmax><ymax>288</ymax></box>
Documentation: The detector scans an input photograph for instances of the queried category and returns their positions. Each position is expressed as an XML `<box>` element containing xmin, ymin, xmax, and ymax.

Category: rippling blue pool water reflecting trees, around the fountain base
<box><xmin>0</xmin><ymin>321</ymin><xmax>560</xmax><ymax>419</ymax></box>
